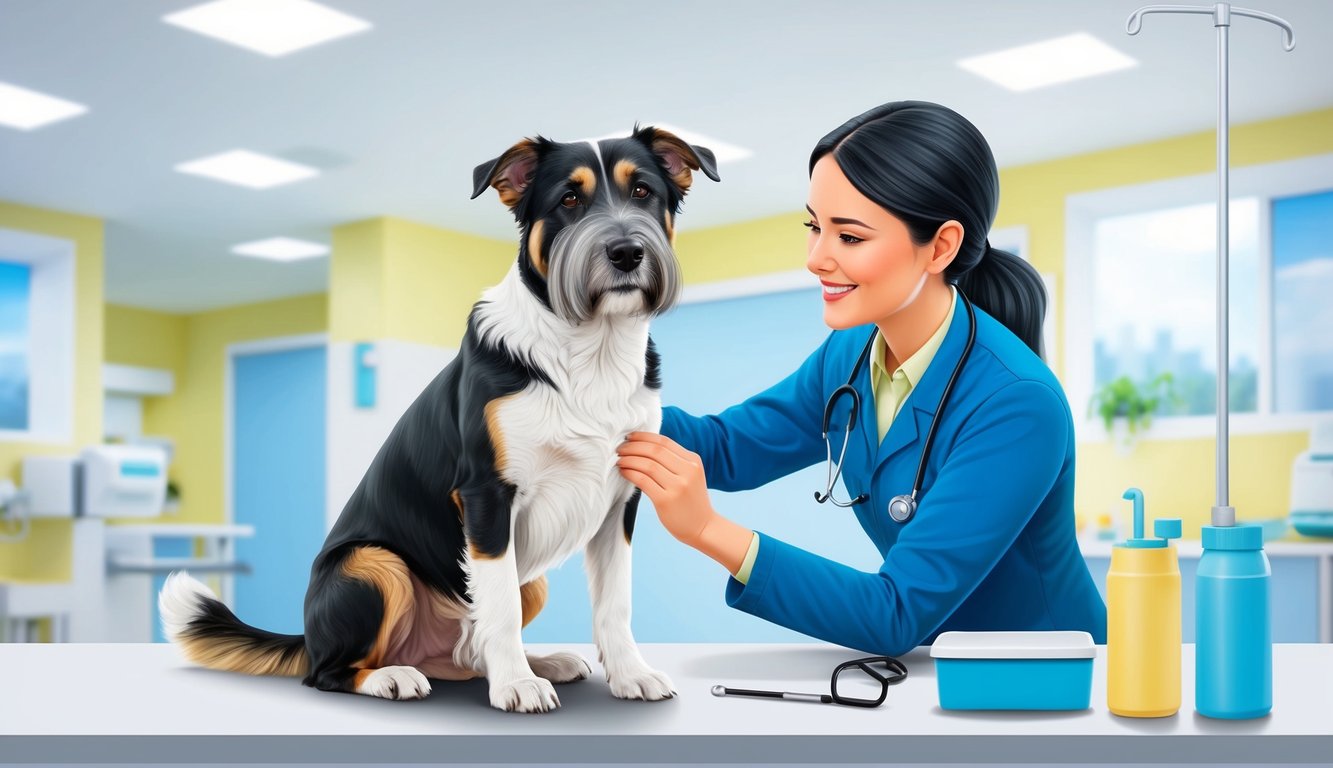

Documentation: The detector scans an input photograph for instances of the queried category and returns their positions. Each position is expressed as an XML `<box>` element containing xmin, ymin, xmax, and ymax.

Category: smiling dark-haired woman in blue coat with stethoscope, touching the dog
<box><xmin>617</xmin><ymin>101</ymin><xmax>1106</xmax><ymax>655</ymax></box>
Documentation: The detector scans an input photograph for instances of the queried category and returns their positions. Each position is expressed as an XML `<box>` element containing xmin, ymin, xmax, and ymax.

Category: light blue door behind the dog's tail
<box><xmin>232</xmin><ymin>345</ymin><xmax>327</xmax><ymax>635</ymax></box>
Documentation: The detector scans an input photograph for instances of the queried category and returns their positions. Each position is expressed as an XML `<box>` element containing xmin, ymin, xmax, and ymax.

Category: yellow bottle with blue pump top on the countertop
<box><xmin>1106</xmin><ymin>488</ymin><xmax>1181</xmax><ymax>717</ymax></box>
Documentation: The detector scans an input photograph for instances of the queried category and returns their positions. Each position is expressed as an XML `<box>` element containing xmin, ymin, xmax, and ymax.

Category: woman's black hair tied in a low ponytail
<box><xmin>810</xmin><ymin>101</ymin><xmax>1046</xmax><ymax>356</ymax></box>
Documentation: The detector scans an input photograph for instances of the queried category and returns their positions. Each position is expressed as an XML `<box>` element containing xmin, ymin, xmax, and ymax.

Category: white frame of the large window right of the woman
<box><xmin>1064</xmin><ymin>153</ymin><xmax>1333</xmax><ymax>441</ymax></box>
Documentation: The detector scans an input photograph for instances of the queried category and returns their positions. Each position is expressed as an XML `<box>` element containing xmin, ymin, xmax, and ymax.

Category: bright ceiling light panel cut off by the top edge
<box><xmin>163</xmin><ymin>0</ymin><xmax>371</xmax><ymax>56</ymax></box>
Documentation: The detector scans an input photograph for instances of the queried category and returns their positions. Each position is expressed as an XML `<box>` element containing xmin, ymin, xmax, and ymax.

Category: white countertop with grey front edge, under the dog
<box><xmin>0</xmin><ymin>644</ymin><xmax>1333</xmax><ymax>764</ymax></box>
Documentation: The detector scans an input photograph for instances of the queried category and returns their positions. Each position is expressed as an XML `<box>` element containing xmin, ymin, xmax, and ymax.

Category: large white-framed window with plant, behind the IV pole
<box><xmin>1064</xmin><ymin>156</ymin><xmax>1333</xmax><ymax>439</ymax></box>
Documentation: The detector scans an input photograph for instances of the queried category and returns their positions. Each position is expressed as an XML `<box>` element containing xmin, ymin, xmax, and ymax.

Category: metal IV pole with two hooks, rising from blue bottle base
<box><xmin>1125</xmin><ymin>3</ymin><xmax>1296</xmax><ymax>720</ymax></box>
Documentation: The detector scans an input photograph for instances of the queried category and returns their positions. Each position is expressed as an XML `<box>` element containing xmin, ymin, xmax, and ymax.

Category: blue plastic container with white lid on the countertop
<box><xmin>930</xmin><ymin>632</ymin><xmax>1097</xmax><ymax>709</ymax></box>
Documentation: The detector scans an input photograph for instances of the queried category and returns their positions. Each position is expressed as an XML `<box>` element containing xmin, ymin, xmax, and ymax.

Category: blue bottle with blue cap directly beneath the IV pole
<box><xmin>1194</xmin><ymin>525</ymin><xmax>1273</xmax><ymax>720</ymax></box>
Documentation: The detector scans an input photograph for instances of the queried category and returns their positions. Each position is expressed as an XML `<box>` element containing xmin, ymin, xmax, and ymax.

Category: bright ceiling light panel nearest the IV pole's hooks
<box><xmin>958</xmin><ymin>32</ymin><xmax>1138</xmax><ymax>91</ymax></box>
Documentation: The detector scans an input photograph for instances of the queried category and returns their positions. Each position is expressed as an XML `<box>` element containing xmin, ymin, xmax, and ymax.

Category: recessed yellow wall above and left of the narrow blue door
<box><xmin>107</xmin><ymin>293</ymin><xmax>328</xmax><ymax>523</ymax></box>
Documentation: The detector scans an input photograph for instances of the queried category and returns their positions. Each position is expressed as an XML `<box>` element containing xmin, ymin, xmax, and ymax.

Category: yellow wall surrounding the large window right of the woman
<box><xmin>996</xmin><ymin>109</ymin><xmax>1333</xmax><ymax>537</ymax></box>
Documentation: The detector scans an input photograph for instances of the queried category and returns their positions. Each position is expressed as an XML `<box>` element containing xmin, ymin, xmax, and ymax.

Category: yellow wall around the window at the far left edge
<box><xmin>0</xmin><ymin>201</ymin><xmax>103</xmax><ymax>579</ymax></box>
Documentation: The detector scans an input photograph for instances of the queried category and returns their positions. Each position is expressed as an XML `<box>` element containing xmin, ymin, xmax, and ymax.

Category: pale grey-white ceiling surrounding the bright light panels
<box><xmin>0</xmin><ymin>0</ymin><xmax>1333</xmax><ymax>312</ymax></box>
